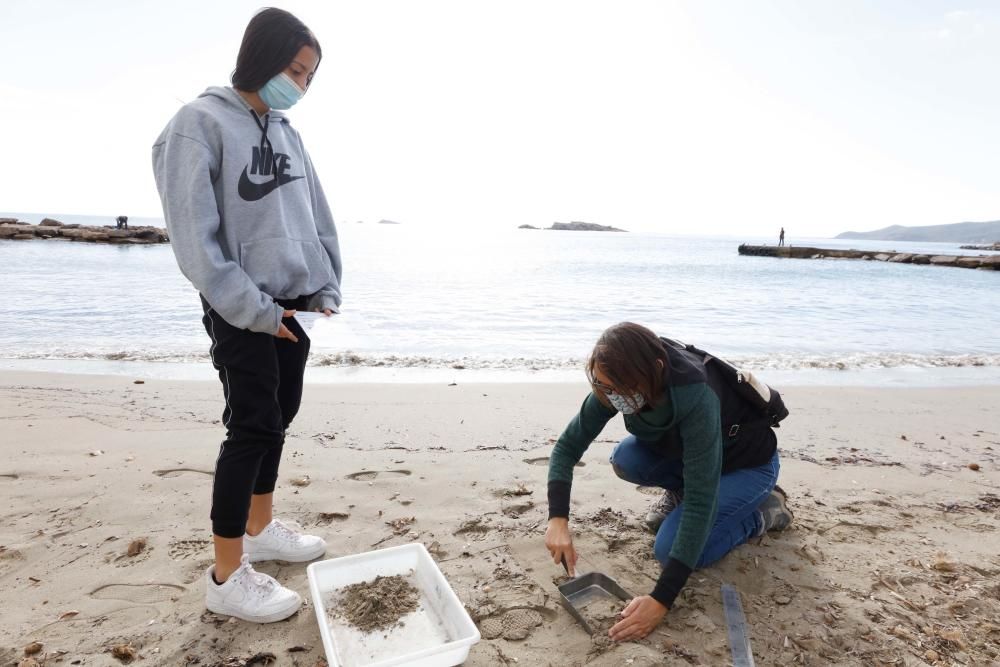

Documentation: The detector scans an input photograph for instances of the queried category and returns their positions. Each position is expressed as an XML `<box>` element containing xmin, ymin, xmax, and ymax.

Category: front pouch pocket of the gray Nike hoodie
<box><xmin>240</xmin><ymin>238</ymin><xmax>333</xmax><ymax>298</ymax></box>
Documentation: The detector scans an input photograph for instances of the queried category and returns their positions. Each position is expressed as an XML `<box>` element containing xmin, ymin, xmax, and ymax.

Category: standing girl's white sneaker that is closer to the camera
<box><xmin>205</xmin><ymin>554</ymin><xmax>302</xmax><ymax>623</ymax></box>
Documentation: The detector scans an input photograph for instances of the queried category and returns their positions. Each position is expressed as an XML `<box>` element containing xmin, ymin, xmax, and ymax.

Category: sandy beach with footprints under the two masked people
<box><xmin>0</xmin><ymin>372</ymin><xmax>1000</xmax><ymax>667</ymax></box>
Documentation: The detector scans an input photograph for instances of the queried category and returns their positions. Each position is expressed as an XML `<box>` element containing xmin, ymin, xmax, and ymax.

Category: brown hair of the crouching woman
<box><xmin>587</xmin><ymin>322</ymin><xmax>667</xmax><ymax>412</ymax></box>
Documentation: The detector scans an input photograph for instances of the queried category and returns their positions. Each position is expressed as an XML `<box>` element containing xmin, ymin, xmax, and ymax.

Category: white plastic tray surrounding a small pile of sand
<box><xmin>306</xmin><ymin>542</ymin><xmax>479</xmax><ymax>667</ymax></box>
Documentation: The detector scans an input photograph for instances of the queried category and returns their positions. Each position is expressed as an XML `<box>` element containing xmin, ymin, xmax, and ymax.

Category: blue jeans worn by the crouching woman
<box><xmin>611</xmin><ymin>435</ymin><xmax>781</xmax><ymax>568</ymax></box>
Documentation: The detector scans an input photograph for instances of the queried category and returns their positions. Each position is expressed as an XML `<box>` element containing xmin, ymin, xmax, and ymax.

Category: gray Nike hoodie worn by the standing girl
<box><xmin>153</xmin><ymin>87</ymin><xmax>341</xmax><ymax>334</ymax></box>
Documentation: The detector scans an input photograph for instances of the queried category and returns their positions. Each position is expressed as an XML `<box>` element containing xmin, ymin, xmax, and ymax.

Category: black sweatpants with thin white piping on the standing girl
<box><xmin>201</xmin><ymin>297</ymin><xmax>309</xmax><ymax>537</ymax></box>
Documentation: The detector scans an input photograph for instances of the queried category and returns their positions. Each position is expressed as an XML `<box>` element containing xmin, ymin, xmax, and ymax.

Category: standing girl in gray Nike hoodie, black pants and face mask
<box><xmin>153</xmin><ymin>8</ymin><xmax>341</xmax><ymax>623</ymax></box>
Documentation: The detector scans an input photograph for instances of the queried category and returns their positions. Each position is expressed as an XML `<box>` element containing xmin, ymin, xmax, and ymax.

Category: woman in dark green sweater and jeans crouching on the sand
<box><xmin>545</xmin><ymin>322</ymin><xmax>792</xmax><ymax>641</ymax></box>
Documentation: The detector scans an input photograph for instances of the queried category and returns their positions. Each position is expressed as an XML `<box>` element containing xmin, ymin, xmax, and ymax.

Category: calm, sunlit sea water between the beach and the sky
<box><xmin>0</xmin><ymin>218</ymin><xmax>1000</xmax><ymax>384</ymax></box>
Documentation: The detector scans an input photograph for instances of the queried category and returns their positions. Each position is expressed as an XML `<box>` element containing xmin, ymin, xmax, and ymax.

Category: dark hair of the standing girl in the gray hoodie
<box><xmin>230</xmin><ymin>7</ymin><xmax>323</xmax><ymax>93</ymax></box>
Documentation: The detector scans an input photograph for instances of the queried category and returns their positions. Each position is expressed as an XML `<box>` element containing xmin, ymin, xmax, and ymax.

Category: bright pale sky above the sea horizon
<box><xmin>0</xmin><ymin>0</ymin><xmax>1000</xmax><ymax>238</ymax></box>
